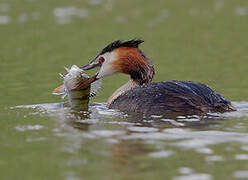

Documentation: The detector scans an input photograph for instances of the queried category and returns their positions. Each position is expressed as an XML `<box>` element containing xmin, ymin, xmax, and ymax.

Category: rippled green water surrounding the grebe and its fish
<box><xmin>0</xmin><ymin>0</ymin><xmax>248</xmax><ymax>180</ymax></box>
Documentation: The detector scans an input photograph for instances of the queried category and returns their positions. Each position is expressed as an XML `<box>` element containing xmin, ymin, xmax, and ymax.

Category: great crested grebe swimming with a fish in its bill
<box><xmin>75</xmin><ymin>39</ymin><xmax>235</xmax><ymax>115</ymax></box>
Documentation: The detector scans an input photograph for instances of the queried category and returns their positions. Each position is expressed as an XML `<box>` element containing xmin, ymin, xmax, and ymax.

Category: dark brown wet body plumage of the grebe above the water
<box><xmin>109</xmin><ymin>81</ymin><xmax>235</xmax><ymax>115</ymax></box>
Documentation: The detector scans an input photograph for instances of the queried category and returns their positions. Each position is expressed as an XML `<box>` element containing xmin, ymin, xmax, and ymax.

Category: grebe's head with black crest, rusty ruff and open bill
<box><xmin>74</xmin><ymin>39</ymin><xmax>154</xmax><ymax>88</ymax></box>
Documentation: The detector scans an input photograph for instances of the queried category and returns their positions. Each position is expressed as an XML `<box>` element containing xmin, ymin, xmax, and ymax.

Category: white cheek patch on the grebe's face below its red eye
<box><xmin>97</xmin><ymin>52</ymin><xmax>116</xmax><ymax>79</ymax></box>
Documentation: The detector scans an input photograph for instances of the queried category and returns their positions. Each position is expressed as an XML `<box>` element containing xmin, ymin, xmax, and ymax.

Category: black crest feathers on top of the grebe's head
<box><xmin>99</xmin><ymin>39</ymin><xmax>144</xmax><ymax>55</ymax></box>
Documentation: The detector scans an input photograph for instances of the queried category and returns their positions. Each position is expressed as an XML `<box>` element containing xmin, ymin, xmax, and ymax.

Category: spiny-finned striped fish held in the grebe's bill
<box><xmin>52</xmin><ymin>65</ymin><xmax>102</xmax><ymax>110</ymax></box>
